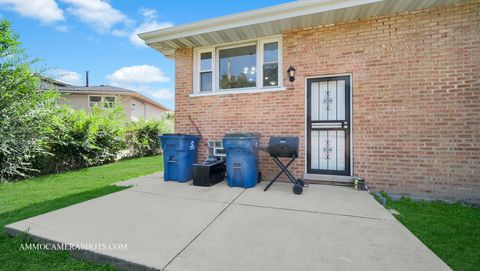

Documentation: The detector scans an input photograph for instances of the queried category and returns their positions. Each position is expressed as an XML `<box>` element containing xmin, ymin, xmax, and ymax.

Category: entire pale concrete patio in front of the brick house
<box><xmin>6</xmin><ymin>174</ymin><xmax>449</xmax><ymax>271</ymax></box>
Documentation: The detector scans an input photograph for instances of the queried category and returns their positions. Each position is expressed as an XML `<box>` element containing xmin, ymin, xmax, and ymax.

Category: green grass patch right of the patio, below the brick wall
<box><xmin>387</xmin><ymin>198</ymin><xmax>480</xmax><ymax>271</ymax></box>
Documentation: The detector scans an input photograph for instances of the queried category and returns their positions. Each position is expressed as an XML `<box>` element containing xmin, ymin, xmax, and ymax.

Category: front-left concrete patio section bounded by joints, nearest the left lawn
<box><xmin>6</xmin><ymin>190</ymin><xmax>231</xmax><ymax>269</ymax></box>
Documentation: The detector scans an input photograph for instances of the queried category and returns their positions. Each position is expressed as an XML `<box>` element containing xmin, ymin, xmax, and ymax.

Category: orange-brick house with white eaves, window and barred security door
<box><xmin>139</xmin><ymin>0</ymin><xmax>480</xmax><ymax>203</ymax></box>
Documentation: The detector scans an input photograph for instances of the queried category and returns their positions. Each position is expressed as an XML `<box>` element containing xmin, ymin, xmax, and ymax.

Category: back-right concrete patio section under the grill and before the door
<box><xmin>235</xmin><ymin>182</ymin><xmax>395</xmax><ymax>220</ymax></box>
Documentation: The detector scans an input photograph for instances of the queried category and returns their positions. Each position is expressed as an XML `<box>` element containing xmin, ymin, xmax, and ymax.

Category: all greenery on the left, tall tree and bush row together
<box><xmin>0</xmin><ymin>20</ymin><xmax>173</xmax><ymax>182</ymax></box>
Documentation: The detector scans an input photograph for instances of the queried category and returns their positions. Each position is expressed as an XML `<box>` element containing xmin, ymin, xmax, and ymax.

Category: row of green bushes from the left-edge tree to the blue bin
<box><xmin>34</xmin><ymin>105</ymin><xmax>173</xmax><ymax>174</ymax></box>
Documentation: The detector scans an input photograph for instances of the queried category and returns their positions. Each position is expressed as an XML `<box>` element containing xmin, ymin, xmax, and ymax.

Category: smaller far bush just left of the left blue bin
<box><xmin>125</xmin><ymin>115</ymin><xmax>173</xmax><ymax>157</ymax></box>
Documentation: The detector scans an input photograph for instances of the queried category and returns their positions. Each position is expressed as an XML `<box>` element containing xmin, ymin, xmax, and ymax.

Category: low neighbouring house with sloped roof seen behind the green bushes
<box><xmin>41</xmin><ymin>77</ymin><xmax>170</xmax><ymax>121</ymax></box>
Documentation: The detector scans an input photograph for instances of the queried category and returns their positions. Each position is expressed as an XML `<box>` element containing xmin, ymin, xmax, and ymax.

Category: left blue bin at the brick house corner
<box><xmin>160</xmin><ymin>134</ymin><xmax>200</xmax><ymax>182</ymax></box>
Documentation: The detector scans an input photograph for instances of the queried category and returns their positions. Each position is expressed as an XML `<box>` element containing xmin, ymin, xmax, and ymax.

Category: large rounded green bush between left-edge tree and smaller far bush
<box><xmin>37</xmin><ymin>107</ymin><xmax>125</xmax><ymax>173</ymax></box>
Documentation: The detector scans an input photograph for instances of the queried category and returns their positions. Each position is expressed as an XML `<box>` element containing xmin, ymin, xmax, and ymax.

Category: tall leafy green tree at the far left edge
<box><xmin>0</xmin><ymin>20</ymin><xmax>59</xmax><ymax>182</ymax></box>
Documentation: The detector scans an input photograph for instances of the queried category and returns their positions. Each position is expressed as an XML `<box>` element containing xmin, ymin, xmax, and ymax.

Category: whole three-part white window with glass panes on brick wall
<box><xmin>194</xmin><ymin>37</ymin><xmax>282</xmax><ymax>94</ymax></box>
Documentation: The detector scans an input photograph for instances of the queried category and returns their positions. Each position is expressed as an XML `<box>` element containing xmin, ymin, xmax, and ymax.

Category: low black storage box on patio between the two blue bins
<box><xmin>193</xmin><ymin>160</ymin><xmax>225</xmax><ymax>186</ymax></box>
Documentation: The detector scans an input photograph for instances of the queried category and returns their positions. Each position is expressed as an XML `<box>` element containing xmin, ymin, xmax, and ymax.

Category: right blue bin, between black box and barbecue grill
<box><xmin>222</xmin><ymin>133</ymin><xmax>260</xmax><ymax>188</ymax></box>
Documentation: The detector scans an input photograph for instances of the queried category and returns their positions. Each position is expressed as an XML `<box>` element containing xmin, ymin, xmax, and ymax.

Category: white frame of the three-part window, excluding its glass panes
<box><xmin>191</xmin><ymin>35</ymin><xmax>285</xmax><ymax>96</ymax></box>
